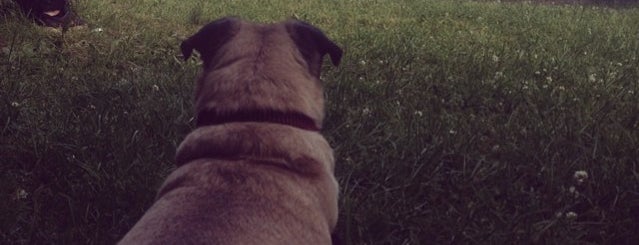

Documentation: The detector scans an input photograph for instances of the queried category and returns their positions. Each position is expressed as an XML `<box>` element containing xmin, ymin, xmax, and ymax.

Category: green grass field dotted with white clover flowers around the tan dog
<box><xmin>0</xmin><ymin>0</ymin><xmax>639</xmax><ymax>244</ymax></box>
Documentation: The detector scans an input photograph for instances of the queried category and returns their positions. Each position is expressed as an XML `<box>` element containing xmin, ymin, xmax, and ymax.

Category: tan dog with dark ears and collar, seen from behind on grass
<box><xmin>120</xmin><ymin>18</ymin><xmax>342</xmax><ymax>244</ymax></box>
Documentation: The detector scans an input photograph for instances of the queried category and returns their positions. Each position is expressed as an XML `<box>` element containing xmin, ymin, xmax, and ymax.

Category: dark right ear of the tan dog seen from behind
<box><xmin>287</xmin><ymin>20</ymin><xmax>343</xmax><ymax>72</ymax></box>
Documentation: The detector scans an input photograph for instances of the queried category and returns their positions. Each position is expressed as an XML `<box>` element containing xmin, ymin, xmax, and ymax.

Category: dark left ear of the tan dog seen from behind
<box><xmin>180</xmin><ymin>17</ymin><xmax>237</xmax><ymax>62</ymax></box>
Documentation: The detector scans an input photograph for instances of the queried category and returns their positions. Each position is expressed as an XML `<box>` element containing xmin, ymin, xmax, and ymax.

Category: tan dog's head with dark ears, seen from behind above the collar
<box><xmin>180</xmin><ymin>17</ymin><xmax>342</xmax><ymax>128</ymax></box>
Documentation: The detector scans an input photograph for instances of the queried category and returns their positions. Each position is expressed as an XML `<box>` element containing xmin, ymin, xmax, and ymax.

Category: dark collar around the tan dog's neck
<box><xmin>196</xmin><ymin>110</ymin><xmax>321</xmax><ymax>131</ymax></box>
